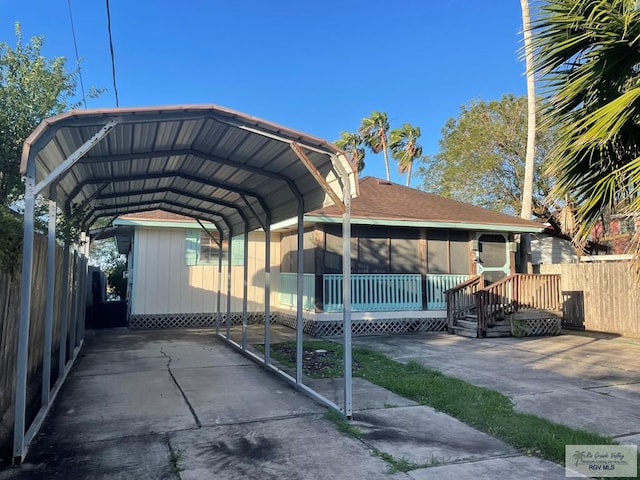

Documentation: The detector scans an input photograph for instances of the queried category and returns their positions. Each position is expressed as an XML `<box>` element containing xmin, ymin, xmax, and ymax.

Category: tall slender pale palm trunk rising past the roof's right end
<box><xmin>520</xmin><ymin>0</ymin><xmax>536</xmax><ymax>272</ymax></box>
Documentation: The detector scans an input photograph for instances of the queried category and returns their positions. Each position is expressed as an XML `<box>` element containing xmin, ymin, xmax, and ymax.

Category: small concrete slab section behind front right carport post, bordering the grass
<box><xmin>305</xmin><ymin>377</ymin><xmax>417</xmax><ymax>412</ymax></box>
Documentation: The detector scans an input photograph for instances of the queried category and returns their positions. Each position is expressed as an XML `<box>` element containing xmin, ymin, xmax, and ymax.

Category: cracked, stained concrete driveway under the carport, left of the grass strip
<box><xmin>0</xmin><ymin>328</ymin><xmax>580</xmax><ymax>480</ymax></box>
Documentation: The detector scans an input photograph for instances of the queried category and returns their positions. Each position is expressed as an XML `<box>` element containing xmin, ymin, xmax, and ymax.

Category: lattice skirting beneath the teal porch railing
<box><xmin>278</xmin><ymin>312</ymin><xmax>447</xmax><ymax>337</ymax></box>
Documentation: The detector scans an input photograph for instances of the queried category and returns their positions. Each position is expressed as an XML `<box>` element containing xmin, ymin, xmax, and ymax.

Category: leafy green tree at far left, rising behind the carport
<box><xmin>0</xmin><ymin>23</ymin><xmax>82</xmax><ymax>205</ymax></box>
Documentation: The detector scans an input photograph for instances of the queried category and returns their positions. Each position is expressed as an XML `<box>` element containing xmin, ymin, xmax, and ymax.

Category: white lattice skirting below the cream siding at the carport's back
<box><xmin>129</xmin><ymin>312</ymin><xmax>278</xmax><ymax>330</ymax></box>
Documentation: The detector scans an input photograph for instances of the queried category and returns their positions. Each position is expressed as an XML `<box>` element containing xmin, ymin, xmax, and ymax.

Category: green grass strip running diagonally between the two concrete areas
<box><xmin>262</xmin><ymin>340</ymin><xmax>628</xmax><ymax>471</ymax></box>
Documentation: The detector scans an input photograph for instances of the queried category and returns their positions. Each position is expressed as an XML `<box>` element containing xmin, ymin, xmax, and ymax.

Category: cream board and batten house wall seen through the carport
<box><xmin>131</xmin><ymin>228</ymin><xmax>280</xmax><ymax>315</ymax></box>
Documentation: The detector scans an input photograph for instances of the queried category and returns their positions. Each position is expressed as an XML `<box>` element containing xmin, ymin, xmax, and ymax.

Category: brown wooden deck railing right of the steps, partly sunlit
<box><xmin>475</xmin><ymin>273</ymin><xmax>562</xmax><ymax>336</ymax></box>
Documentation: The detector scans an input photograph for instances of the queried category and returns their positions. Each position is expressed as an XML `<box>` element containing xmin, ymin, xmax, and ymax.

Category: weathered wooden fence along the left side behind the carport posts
<box><xmin>0</xmin><ymin>235</ymin><xmax>82</xmax><ymax>457</ymax></box>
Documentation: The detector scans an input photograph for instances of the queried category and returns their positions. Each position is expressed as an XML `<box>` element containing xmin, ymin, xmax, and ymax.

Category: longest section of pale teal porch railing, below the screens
<box><xmin>323</xmin><ymin>274</ymin><xmax>422</xmax><ymax>312</ymax></box>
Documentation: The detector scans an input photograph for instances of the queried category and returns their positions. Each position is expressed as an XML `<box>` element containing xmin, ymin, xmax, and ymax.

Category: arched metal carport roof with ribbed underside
<box><xmin>21</xmin><ymin>105</ymin><xmax>358</xmax><ymax>235</ymax></box>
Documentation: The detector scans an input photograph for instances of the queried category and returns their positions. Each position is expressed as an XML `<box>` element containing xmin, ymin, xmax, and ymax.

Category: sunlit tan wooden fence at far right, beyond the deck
<box><xmin>540</xmin><ymin>262</ymin><xmax>640</xmax><ymax>336</ymax></box>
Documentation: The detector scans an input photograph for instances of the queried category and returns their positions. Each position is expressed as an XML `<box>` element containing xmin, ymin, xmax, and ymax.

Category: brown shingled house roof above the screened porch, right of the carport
<box><xmin>307</xmin><ymin>177</ymin><xmax>544</xmax><ymax>232</ymax></box>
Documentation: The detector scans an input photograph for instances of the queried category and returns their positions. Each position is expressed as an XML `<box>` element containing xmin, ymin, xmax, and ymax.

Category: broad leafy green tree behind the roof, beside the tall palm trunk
<box><xmin>418</xmin><ymin>95</ymin><xmax>562</xmax><ymax>218</ymax></box>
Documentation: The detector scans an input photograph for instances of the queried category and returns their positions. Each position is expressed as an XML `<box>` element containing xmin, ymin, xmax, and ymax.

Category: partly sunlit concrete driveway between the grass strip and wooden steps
<box><xmin>354</xmin><ymin>333</ymin><xmax>640</xmax><ymax>445</ymax></box>
